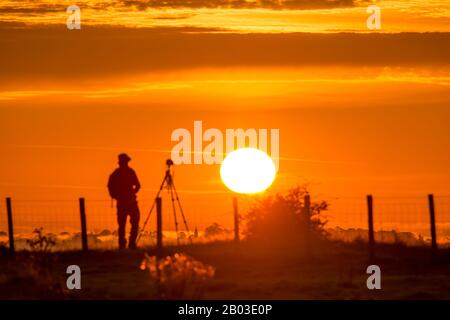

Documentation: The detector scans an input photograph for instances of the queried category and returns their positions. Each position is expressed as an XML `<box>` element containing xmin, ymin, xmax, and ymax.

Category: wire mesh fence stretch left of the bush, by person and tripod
<box><xmin>0</xmin><ymin>194</ymin><xmax>243</xmax><ymax>250</ymax></box>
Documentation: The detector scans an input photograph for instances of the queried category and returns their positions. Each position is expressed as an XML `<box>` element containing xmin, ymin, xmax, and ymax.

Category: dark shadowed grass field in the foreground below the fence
<box><xmin>0</xmin><ymin>242</ymin><xmax>450</xmax><ymax>299</ymax></box>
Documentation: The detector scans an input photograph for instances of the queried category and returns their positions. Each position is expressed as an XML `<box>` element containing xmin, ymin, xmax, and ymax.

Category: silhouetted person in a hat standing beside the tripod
<box><xmin>108</xmin><ymin>153</ymin><xmax>141</xmax><ymax>249</ymax></box>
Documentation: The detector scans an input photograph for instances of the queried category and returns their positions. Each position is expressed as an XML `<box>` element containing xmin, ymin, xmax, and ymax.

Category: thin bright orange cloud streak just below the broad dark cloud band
<box><xmin>0</xmin><ymin>68</ymin><xmax>450</xmax><ymax>101</ymax></box>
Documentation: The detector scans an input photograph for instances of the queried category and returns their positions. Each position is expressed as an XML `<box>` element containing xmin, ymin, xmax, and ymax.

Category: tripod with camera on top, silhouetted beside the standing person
<box><xmin>136</xmin><ymin>159</ymin><xmax>192</xmax><ymax>245</ymax></box>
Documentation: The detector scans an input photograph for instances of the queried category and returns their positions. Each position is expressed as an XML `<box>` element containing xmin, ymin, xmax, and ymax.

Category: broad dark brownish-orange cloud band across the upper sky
<box><xmin>0</xmin><ymin>27</ymin><xmax>450</xmax><ymax>84</ymax></box>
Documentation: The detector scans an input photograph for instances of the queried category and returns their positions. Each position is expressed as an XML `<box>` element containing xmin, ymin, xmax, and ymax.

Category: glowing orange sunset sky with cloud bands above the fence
<box><xmin>0</xmin><ymin>0</ymin><xmax>450</xmax><ymax>235</ymax></box>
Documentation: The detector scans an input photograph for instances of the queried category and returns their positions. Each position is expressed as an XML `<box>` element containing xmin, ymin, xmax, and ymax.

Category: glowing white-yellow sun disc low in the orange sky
<box><xmin>220</xmin><ymin>148</ymin><xmax>276</xmax><ymax>194</ymax></box>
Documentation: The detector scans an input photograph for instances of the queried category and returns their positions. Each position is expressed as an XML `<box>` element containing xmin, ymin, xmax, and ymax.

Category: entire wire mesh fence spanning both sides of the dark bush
<box><xmin>0</xmin><ymin>194</ymin><xmax>450</xmax><ymax>250</ymax></box>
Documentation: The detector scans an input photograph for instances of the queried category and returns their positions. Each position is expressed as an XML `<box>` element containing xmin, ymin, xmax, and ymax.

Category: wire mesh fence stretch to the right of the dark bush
<box><xmin>323</xmin><ymin>196</ymin><xmax>450</xmax><ymax>245</ymax></box>
